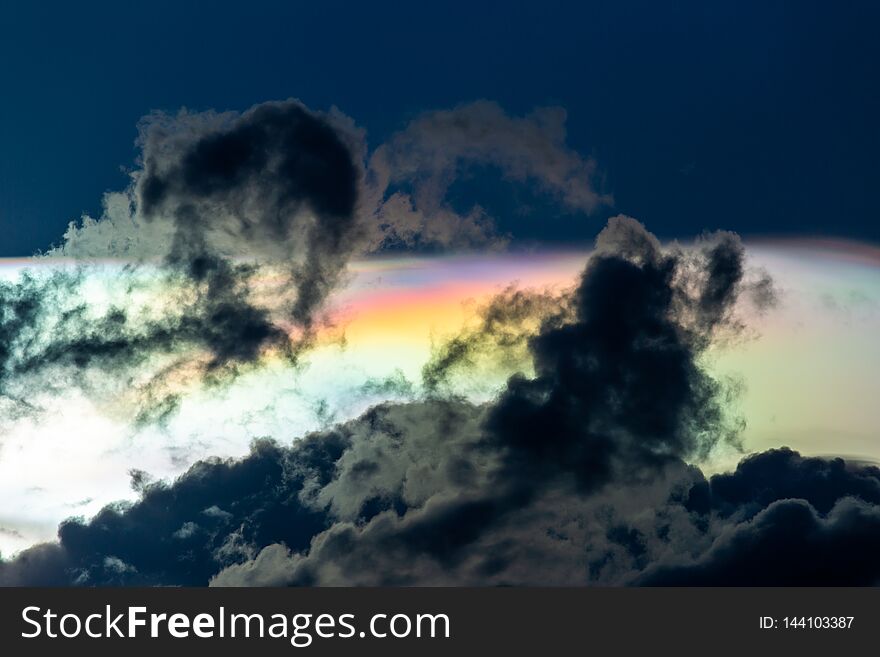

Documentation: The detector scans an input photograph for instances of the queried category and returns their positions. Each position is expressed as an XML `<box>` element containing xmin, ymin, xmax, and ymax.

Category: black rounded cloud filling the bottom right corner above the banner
<box><xmin>634</xmin><ymin>449</ymin><xmax>880</xmax><ymax>586</ymax></box>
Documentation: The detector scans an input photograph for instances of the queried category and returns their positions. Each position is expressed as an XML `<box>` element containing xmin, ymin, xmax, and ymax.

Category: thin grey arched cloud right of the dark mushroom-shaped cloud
<box><xmin>367</xmin><ymin>101</ymin><xmax>612</xmax><ymax>247</ymax></box>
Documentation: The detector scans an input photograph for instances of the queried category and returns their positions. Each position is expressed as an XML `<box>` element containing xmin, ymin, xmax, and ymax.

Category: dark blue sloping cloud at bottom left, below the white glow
<box><xmin>0</xmin><ymin>436</ymin><xmax>344</xmax><ymax>585</ymax></box>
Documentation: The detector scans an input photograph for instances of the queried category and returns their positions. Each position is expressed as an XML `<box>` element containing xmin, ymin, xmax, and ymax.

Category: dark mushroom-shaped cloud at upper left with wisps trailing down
<box><xmin>136</xmin><ymin>101</ymin><xmax>363</xmax><ymax>326</ymax></box>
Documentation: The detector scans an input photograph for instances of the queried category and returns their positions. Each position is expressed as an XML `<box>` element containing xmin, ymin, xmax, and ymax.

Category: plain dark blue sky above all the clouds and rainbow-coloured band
<box><xmin>0</xmin><ymin>0</ymin><xmax>880</xmax><ymax>255</ymax></box>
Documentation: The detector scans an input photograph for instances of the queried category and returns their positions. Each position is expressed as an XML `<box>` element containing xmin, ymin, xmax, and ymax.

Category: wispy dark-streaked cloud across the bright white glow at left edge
<box><xmin>0</xmin><ymin>254</ymin><xmax>286</xmax><ymax>418</ymax></box>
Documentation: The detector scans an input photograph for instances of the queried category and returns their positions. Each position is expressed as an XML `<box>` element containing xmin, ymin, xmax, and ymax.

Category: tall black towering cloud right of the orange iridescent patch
<box><xmin>488</xmin><ymin>217</ymin><xmax>744</xmax><ymax>488</ymax></box>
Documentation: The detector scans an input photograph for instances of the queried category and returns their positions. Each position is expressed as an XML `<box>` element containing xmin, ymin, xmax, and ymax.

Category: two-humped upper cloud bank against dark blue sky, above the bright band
<box><xmin>50</xmin><ymin>100</ymin><xmax>612</xmax><ymax>258</ymax></box>
